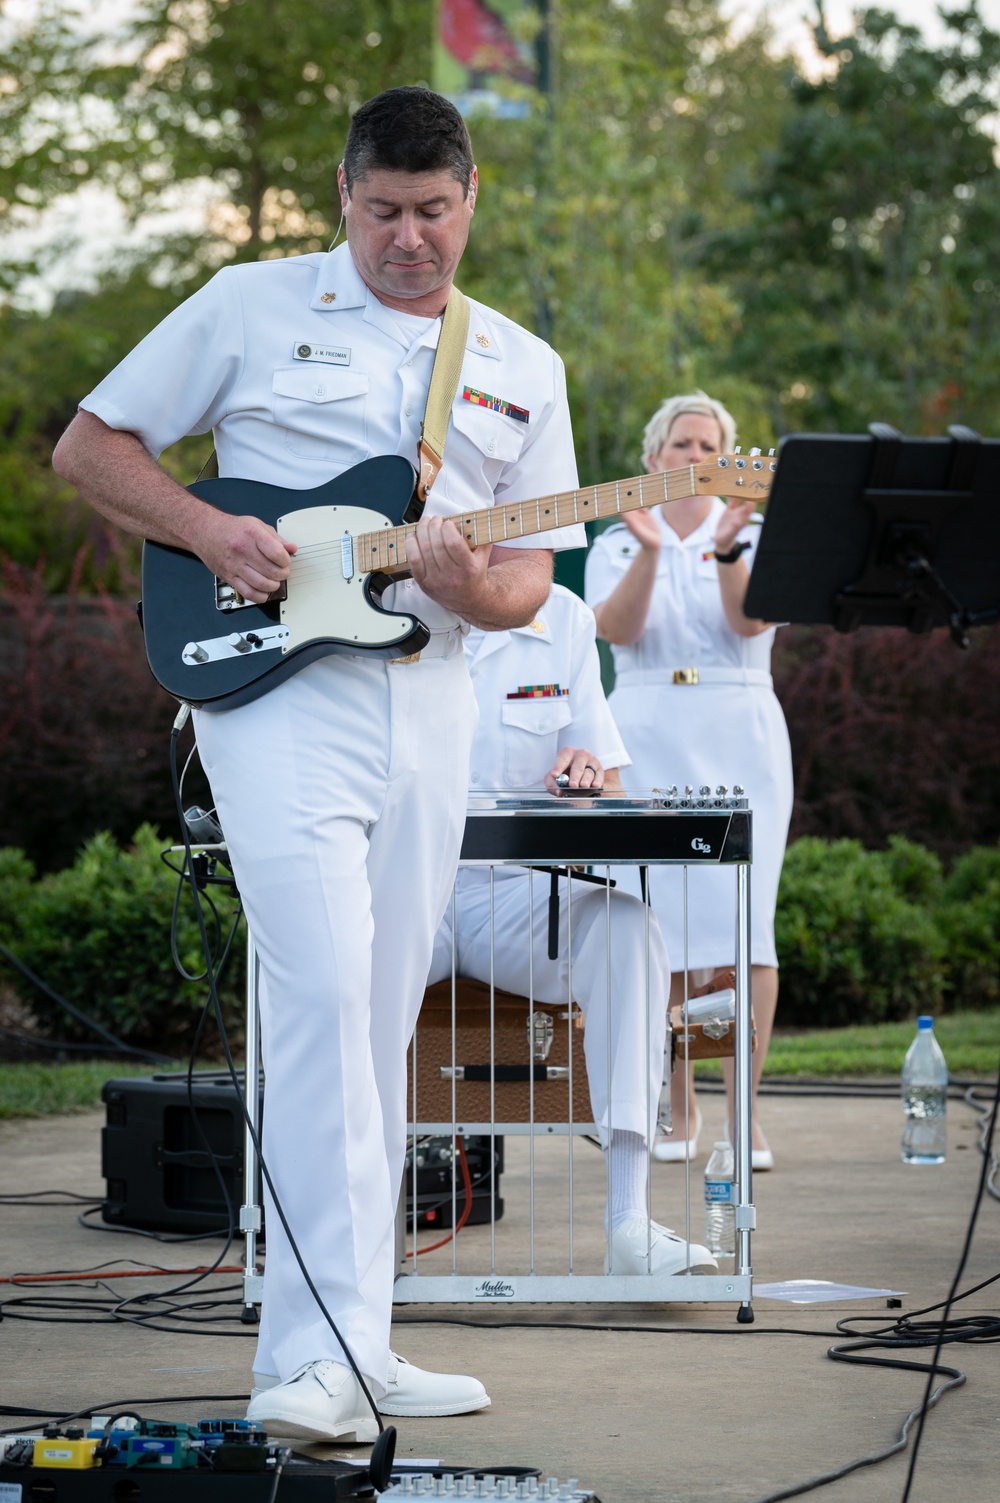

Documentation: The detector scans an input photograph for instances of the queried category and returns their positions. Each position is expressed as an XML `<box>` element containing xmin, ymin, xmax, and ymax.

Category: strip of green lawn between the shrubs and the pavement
<box><xmin>0</xmin><ymin>1007</ymin><xmax>1000</xmax><ymax>1118</ymax></box>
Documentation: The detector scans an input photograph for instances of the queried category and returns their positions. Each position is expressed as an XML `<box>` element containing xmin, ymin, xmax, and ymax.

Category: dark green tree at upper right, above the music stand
<box><xmin>710</xmin><ymin>5</ymin><xmax>1000</xmax><ymax>433</ymax></box>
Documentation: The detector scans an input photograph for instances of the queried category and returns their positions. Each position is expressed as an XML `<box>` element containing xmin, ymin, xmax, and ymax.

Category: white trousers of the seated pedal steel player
<box><xmin>429</xmin><ymin>867</ymin><xmax>671</xmax><ymax>1147</ymax></box>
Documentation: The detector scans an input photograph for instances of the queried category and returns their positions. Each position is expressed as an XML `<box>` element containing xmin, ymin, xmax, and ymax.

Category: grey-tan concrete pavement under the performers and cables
<box><xmin>0</xmin><ymin>1096</ymin><xmax>1000</xmax><ymax>1503</ymax></box>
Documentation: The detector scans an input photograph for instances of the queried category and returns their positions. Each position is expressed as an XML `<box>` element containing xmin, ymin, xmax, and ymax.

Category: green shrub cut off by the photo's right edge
<box><xmin>938</xmin><ymin>846</ymin><xmax>1000</xmax><ymax>1007</ymax></box>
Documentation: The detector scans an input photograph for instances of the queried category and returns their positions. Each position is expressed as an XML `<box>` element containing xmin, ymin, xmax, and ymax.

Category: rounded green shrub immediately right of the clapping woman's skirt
<box><xmin>776</xmin><ymin>836</ymin><xmax>946</xmax><ymax>1028</ymax></box>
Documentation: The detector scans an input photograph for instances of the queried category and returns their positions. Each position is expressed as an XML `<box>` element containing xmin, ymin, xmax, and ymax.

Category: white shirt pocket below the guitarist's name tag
<box><xmin>271</xmin><ymin>362</ymin><xmax>368</xmax><ymax>467</ymax></box>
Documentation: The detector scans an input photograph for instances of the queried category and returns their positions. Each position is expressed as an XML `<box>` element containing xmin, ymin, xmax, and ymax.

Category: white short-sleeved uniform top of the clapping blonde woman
<box><xmin>586</xmin><ymin>497</ymin><xmax>774</xmax><ymax>673</ymax></box>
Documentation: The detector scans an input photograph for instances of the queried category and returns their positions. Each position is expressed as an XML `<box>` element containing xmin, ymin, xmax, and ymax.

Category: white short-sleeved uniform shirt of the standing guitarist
<box><xmin>80</xmin><ymin>245</ymin><xmax>586</xmax><ymax>631</ymax></box>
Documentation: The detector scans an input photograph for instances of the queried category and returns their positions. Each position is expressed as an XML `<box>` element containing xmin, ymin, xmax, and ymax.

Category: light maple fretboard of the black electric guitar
<box><xmin>355</xmin><ymin>464</ymin><xmax>714</xmax><ymax>574</ymax></box>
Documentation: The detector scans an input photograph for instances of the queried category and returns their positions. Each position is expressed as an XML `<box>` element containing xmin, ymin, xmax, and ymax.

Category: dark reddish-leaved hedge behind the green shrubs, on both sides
<box><xmin>0</xmin><ymin>552</ymin><xmax>1000</xmax><ymax>869</ymax></box>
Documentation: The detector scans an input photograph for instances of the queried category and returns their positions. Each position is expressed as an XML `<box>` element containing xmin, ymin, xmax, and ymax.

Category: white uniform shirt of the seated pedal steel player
<box><xmin>465</xmin><ymin>585</ymin><xmax>630</xmax><ymax>793</ymax></box>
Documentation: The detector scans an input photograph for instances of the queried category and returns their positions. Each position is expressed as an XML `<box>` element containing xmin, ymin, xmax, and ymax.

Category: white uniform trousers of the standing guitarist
<box><xmin>197</xmin><ymin>652</ymin><xmax>478</xmax><ymax>1393</ymax></box>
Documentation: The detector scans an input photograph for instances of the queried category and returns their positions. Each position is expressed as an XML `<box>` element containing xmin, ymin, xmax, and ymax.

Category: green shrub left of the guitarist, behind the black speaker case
<box><xmin>0</xmin><ymin>825</ymin><xmax>242</xmax><ymax>1049</ymax></box>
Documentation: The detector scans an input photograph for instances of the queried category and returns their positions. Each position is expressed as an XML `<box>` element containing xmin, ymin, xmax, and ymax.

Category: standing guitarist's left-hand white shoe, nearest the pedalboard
<box><xmin>247</xmin><ymin>1362</ymin><xmax>379</xmax><ymax>1444</ymax></box>
